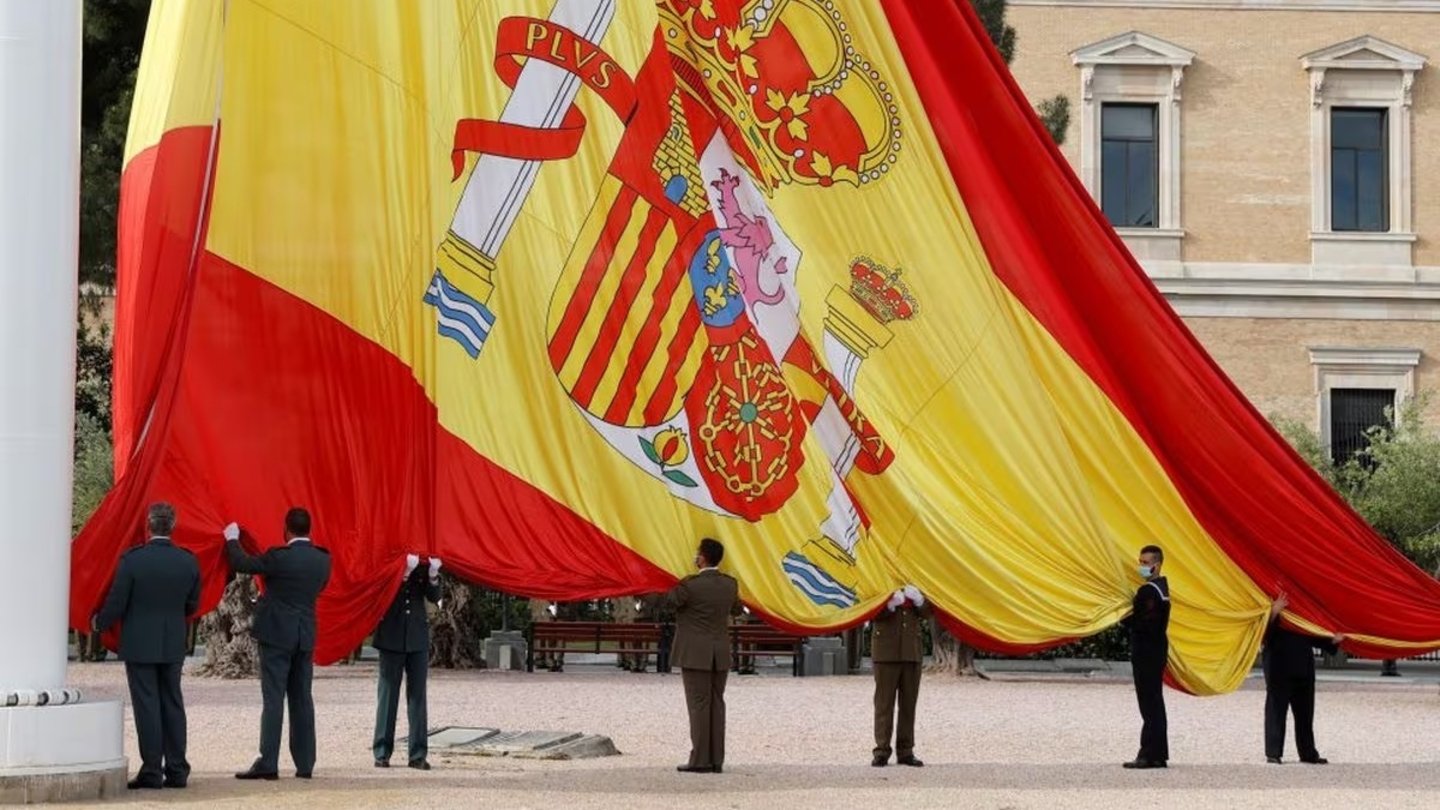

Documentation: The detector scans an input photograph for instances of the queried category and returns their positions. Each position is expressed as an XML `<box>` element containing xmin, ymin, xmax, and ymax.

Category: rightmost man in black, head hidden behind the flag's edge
<box><xmin>1260</xmin><ymin>594</ymin><xmax>1345</xmax><ymax>765</ymax></box>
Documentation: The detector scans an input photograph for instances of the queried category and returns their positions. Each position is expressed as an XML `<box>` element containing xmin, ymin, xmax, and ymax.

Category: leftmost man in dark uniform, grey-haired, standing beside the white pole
<box><xmin>91</xmin><ymin>503</ymin><xmax>200</xmax><ymax>790</ymax></box>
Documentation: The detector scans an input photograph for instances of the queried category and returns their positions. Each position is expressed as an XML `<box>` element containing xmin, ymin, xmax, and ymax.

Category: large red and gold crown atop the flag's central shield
<box><xmin>658</xmin><ymin>0</ymin><xmax>901</xmax><ymax>190</ymax></box>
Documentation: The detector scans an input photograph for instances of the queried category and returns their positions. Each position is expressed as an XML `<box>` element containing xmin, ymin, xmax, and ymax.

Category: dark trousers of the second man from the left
<box><xmin>258</xmin><ymin>644</ymin><xmax>315</xmax><ymax>774</ymax></box>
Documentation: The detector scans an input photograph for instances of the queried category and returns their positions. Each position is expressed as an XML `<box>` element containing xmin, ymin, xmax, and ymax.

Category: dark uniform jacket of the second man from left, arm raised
<box><xmin>225</xmin><ymin>540</ymin><xmax>330</xmax><ymax>651</ymax></box>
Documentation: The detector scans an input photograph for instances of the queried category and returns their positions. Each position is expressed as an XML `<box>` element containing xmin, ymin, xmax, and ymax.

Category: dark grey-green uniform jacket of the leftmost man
<box><xmin>94</xmin><ymin>538</ymin><xmax>200</xmax><ymax>664</ymax></box>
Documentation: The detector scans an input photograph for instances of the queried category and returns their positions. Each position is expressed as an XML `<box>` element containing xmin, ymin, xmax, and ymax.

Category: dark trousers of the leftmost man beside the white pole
<box><xmin>125</xmin><ymin>662</ymin><xmax>190</xmax><ymax>783</ymax></box>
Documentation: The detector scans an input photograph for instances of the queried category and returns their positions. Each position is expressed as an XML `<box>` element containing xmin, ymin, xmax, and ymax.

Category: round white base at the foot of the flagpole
<box><xmin>0</xmin><ymin>700</ymin><xmax>128</xmax><ymax>804</ymax></box>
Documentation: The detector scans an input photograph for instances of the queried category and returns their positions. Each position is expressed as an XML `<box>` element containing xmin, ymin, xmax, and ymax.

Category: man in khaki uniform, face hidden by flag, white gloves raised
<box><xmin>870</xmin><ymin>585</ymin><xmax>924</xmax><ymax>768</ymax></box>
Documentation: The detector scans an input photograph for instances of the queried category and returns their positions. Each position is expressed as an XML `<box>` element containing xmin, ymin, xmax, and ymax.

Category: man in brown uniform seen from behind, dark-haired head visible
<box><xmin>665</xmin><ymin>538</ymin><xmax>740</xmax><ymax>774</ymax></box>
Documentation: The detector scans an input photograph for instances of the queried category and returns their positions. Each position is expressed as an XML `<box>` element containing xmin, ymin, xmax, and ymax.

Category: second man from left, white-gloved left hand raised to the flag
<box><xmin>225</xmin><ymin>507</ymin><xmax>330</xmax><ymax>780</ymax></box>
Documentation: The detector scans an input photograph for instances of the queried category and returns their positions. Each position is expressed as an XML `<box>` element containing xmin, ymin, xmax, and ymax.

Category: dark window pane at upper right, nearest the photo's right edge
<box><xmin>1331</xmin><ymin>108</ymin><xmax>1390</xmax><ymax>233</ymax></box>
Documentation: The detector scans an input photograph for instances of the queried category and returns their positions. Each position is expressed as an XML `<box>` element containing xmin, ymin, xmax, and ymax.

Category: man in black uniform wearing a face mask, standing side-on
<box><xmin>1125</xmin><ymin>546</ymin><xmax>1171</xmax><ymax>768</ymax></box>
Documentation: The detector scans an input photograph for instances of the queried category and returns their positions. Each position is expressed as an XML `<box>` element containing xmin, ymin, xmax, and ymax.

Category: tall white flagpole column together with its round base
<box><xmin>0</xmin><ymin>0</ymin><xmax>125</xmax><ymax>803</ymax></box>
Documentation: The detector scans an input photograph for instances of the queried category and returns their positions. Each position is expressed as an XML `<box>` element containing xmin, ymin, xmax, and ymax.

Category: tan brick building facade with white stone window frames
<box><xmin>1009</xmin><ymin>0</ymin><xmax>1440</xmax><ymax>457</ymax></box>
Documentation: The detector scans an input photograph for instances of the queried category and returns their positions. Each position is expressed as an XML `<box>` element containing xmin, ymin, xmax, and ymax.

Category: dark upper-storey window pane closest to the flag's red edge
<box><xmin>1100</xmin><ymin>104</ymin><xmax>1159</xmax><ymax>228</ymax></box>
